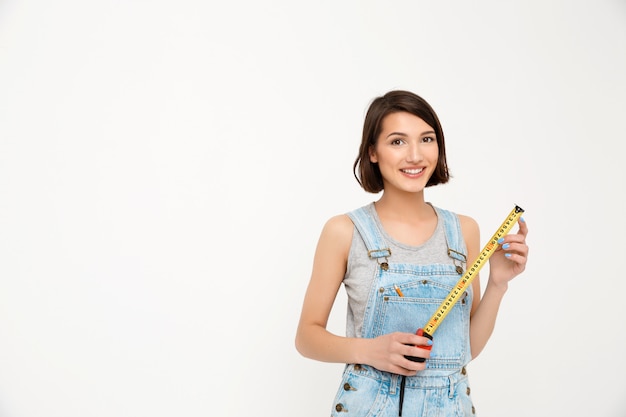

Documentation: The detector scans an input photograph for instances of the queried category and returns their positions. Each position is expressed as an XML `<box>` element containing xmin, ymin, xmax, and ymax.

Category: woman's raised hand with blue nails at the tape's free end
<box><xmin>489</xmin><ymin>218</ymin><xmax>528</xmax><ymax>286</ymax></box>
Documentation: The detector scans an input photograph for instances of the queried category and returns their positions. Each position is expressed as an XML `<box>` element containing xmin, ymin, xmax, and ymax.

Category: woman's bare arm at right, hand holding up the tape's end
<box><xmin>460</xmin><ymin>216</ymin><xmax>528</xmax><ymax>358</ymax></box>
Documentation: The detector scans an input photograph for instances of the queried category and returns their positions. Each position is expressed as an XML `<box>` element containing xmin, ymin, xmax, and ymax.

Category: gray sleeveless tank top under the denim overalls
<box><xmin>343</xmin><ymin>203</ymin><xmax>467</xmax><ymax>337</ymax></box>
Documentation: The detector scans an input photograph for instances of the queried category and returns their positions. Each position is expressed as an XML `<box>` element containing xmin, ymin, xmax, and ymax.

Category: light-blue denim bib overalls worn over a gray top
<box><xmin>331</xmin><ymin>208</ymin><xmax>475</xmax><ymax>417</ymax></box>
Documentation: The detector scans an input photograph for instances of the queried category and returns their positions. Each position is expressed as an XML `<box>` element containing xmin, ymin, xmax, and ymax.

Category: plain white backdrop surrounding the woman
<box><xmin>0</xmin><ymin>0</ymin><xmax>626</xmax><ymax>417</ymax></box>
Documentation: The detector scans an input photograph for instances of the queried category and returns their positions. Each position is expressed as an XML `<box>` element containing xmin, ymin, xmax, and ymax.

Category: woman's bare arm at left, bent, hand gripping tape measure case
<box><xmin>295</xmin><ymin>216</ymin><xmax>430</xmax><ymax>375</ymax></box>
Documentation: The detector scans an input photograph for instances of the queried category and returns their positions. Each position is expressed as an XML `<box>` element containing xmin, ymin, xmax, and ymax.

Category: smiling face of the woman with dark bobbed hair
<box><xmin>370</xmin><ymin>112</ymin><xmax>439</xmax><ymax>193</ymax></box>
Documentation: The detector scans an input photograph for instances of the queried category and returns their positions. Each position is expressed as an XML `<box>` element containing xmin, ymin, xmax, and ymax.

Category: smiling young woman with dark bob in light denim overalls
<box><xmin>296</xmin><ymin>91</ymin><xmax>528</xmax><ymax>417</ymax></box>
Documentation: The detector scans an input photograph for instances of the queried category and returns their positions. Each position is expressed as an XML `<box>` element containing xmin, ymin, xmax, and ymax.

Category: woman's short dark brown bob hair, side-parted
<box><xmin>353</xmin><ymin>90</ymin><xmax>450</xmax><ymax>193</ymax></box>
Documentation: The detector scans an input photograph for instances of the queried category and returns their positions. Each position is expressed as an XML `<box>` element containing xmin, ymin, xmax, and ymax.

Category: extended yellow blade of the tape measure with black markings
<box><xmin>423</xmin><ymin>205</ymin><xmax>524</xmax><ymax>336</ymax></box>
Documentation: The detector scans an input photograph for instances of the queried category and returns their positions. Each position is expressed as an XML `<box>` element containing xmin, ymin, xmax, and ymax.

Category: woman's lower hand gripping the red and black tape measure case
<box><xmin>363</xmin><ymin>332</ymin><xmax>432</xmax><ymax>376</ymax></box>
